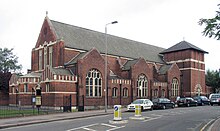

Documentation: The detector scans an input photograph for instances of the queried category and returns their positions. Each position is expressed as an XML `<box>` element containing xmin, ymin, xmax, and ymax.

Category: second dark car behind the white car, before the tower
<box><xmin>177</xmin><ymin>97</ymin><xmax>198</xmax><ymax>107</ymax></box>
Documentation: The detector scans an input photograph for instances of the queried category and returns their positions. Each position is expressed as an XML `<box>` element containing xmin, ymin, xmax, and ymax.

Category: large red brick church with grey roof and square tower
<box><xmin>9</xmin><ymin>16</ymin><xmax>207</xmax><ymax>109</ymax></box>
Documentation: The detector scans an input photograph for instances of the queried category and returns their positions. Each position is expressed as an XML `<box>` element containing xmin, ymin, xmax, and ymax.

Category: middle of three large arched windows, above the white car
<box><xmin>137</xmin><ymin>74</ymin><xmax>148</xmax><ymax>97</ymax></box>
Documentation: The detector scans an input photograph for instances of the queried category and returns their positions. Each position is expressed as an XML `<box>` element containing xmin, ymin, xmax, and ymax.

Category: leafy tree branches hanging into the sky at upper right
<box><xmin>199</xmin><ymin>4</ymin><xmax>220</xmax><ymax>40</ymax></box>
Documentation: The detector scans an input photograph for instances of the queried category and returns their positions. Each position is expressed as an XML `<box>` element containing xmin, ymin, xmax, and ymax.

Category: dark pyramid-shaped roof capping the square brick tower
<box><xmin>160</xmin><ymin>41</ymin><xmax>208</xmax><ymax>54</ymax></box>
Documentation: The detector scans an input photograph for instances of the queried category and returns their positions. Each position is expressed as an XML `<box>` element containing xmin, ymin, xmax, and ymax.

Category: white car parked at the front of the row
<box><xmin>127</xmin><ymin>99</ymin><xmax>153</xmax><ymax>111</ymax></box>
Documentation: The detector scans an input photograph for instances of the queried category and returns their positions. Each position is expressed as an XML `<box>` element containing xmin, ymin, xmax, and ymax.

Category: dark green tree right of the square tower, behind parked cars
<box><xmin>205</xmin><ymin>70</ymin><xmax>220</xmax><ymax>92</ymax></box>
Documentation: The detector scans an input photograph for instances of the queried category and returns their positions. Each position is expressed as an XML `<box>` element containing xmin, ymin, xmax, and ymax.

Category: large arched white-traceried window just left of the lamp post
<box><xmin>86</xmin><ymin>69</ymin><xmax>102</xmax><ymax>97</ymax></box>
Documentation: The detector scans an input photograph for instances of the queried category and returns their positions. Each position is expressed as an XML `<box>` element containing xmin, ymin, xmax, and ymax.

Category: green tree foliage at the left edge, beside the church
<box><xmin>0</xmin><ymin>48</ymin><xmax>22</xmax><ymax>73</ymax></box>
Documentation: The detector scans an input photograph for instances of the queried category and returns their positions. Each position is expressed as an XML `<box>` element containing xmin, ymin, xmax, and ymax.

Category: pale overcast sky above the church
<box><xmin>0</xmin><ymin>0</ymin><xmax>220</xmax><ymax>73</ymax></box>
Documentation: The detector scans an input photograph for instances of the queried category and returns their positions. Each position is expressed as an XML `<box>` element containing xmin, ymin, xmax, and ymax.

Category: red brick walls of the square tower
<box><xmin>164</xmin><ymin>50</ymin><xmax>205</xmax><ymax>96</ymax></box>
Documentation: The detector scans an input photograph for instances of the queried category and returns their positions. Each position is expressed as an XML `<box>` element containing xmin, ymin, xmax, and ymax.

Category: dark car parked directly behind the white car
<box><xmin>152</xmin><ymin>98</ymin><xmax>175</xmax><ymax>109</ymax></box>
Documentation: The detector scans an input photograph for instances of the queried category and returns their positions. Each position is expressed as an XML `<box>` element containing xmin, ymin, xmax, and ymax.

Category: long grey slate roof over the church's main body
<box><xmin>51</xmin><ymin>20</ymin><xmax>164</xmax><ymax>63</ymax></box>
